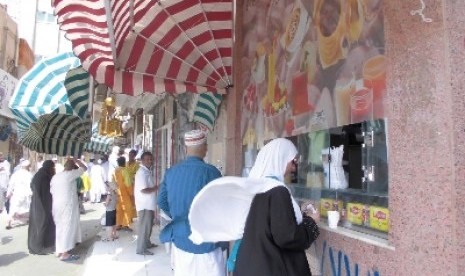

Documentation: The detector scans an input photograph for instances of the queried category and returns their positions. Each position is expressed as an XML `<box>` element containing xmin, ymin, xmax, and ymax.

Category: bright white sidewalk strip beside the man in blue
<box><xmin>84</xmin><ymin>226</ymin><xmax>173</xmax><ymax>276</ymax></box>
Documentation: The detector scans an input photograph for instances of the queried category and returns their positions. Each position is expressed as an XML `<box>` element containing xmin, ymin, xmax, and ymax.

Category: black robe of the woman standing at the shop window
<box><xmin>234</xmin><ymin>186</ymin><xmax>319</xmax><ymax>276</ymax></box>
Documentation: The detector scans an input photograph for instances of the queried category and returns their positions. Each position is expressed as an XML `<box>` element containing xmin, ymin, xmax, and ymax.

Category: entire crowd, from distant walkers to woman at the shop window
<box><xmin>0</xmin><ymin>130</ymin><xmax>319</xmax><ymax>276</ymax></box>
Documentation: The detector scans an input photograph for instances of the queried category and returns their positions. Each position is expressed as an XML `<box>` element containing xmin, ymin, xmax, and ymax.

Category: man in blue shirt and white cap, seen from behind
<box><xmin>158</xmin><ymin>130</ymin><xmax>226</xmax><ymax>276</ymax></box>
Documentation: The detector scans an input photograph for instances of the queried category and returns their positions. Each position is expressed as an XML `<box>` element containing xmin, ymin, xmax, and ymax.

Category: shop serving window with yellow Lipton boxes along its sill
<box><xmin>289</xmin><ymin>119</ymin><xmax>389</xmax><ymax>239</ymax></box>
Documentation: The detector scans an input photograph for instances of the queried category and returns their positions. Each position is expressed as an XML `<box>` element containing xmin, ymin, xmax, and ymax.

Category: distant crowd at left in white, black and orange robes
<box><xmin>0</xmin><ymin>147</ymin><xmax>139</xmax><ymax>261</ymax></box>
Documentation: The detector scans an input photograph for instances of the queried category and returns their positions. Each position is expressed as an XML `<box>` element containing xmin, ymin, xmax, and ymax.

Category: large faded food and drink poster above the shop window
<box><xmin>240</xmin><ymin>0</ymin><xmax>386</xmax><ymax>146</ymax></box>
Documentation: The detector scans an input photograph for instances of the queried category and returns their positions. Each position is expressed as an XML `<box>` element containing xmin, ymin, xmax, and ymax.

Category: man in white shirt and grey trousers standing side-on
<box><xmin>134</xmin><ymin>151</ymin><xmax>157</xmax><ymax>255</ymax></box>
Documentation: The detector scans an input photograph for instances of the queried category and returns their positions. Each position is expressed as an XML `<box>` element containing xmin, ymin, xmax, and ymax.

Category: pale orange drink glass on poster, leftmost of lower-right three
<box><xmin>334</xmin><ymin>78</ymin><xmax>355</xmax><ymax>126</ymax></box>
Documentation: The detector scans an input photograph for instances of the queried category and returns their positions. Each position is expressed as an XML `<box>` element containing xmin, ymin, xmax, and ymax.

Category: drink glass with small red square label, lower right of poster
<box><xmin>350</xmin><ymin>87</ymin><xmax>373</xmax><ymax>124</ymax></box>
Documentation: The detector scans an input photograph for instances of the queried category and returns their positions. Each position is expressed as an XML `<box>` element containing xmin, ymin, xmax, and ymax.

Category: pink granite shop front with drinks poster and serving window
<box><xmin>226</xmin><ymin>0</ymin><xmax>465</xmax><ymax>275</ymax></box>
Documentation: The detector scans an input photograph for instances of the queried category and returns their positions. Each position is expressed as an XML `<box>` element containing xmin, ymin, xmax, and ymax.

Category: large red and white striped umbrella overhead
<box><xmin>52</xmin><ymin>0</ymin><xmax>233</xmax><ymax>96</ymax></box>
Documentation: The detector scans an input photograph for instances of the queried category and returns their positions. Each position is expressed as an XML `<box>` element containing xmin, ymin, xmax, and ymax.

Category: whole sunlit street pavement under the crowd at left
<box><xmin>0</xmin><ymin>203</ymin><xmax>173</xmax><ymax>276</ymax></box>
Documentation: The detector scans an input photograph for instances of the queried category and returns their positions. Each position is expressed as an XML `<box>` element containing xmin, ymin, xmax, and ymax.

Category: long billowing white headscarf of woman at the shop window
<box><xmin>189</xmin><ymin>138</ymin><xmax>302</xmax><ymax>244</ymax></box>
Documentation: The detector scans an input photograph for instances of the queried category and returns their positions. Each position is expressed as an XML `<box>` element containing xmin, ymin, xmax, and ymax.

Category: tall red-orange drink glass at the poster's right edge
<box><xmin>363</xmin><ymin>55</ymin><xmax>386</xmax><ymax>119</ymax></box>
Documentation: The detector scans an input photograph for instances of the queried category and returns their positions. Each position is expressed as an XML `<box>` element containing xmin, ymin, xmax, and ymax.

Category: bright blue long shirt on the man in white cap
<box><xmin>158</xmin><ymin>156</ymin><xmax>221</xmax><ymax>254</ymax></box>
